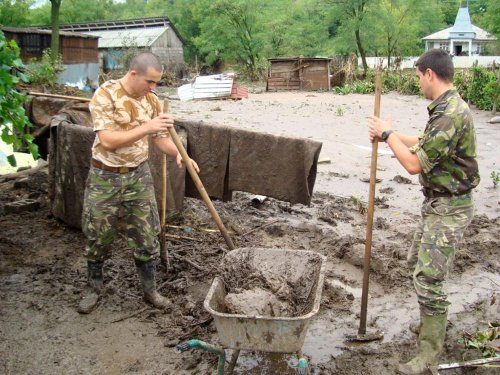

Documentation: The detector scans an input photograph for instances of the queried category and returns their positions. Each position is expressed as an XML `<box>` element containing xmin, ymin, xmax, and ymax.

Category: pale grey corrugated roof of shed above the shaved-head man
<box><xmin>85</xmin><ymin>27</ymin><xmax>168</xmax><ymax>48</ymax></box>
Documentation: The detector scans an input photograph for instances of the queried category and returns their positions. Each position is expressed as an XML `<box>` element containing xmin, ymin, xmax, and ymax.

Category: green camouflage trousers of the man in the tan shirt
<box><xmin>82</xmin><ymin>163</ymin><xmax>160</xmax><ymax>262</ymax></box>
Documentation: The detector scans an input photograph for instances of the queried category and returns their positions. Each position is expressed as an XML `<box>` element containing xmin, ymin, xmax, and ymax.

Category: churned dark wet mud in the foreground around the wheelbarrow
<box><xmin>0</xmin><ymin>169</ymin><xmax>500</xmax><ymax>374</ymax></box>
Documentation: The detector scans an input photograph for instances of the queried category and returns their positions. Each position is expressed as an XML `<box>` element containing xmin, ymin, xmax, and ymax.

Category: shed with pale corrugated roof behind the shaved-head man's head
<box><xmin>56</xmin><ymin>16</ymin><xmax>184</xmax><ymax>71</ymax></box>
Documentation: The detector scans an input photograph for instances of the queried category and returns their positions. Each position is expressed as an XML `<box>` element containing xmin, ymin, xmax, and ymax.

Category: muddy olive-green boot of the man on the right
<box><xmin>398</xmin><ymin>313</ymin><xmax>447</xmax><ymax>375</ymax></box>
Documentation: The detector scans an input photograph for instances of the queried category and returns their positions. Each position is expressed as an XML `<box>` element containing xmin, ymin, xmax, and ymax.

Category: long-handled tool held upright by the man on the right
<box><xmin>347</xmin><ymin>69</ymin><xmax>384</xmax><ymax>342</ymax></box>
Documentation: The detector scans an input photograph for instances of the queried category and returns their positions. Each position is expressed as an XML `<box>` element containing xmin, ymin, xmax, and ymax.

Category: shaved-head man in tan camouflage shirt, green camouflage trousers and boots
<box><xmin>78</xmin><ymin>53</ymin><xmax>199</xmax><ymax>313</ymax></box>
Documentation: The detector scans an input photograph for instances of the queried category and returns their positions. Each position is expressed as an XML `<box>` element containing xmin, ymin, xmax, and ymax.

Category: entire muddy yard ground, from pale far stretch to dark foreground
<box><xmin>0</xmin><ymin>92</ymin><xmax>500</xmax><ymax>375</ymax></box>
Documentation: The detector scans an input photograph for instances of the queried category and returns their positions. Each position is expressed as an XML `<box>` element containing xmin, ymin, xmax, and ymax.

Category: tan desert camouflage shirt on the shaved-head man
<box><xmin>89</xmin><ymin>80</ymin><xmax>161</xmax><ymax>167</ymax></box>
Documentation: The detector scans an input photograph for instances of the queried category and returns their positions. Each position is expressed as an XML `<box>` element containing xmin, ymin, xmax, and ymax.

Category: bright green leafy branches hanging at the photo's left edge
<box><xmin>0</xmin><ymin>31</ymin><xmax>38</xmax><ymax>166</ymax></box>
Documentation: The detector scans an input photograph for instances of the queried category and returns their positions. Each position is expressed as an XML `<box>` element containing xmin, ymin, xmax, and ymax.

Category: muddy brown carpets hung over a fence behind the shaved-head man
<box><xmin>49</xmin><ymin>101</ymin><xmax>321</xmax><ymax>228</ymax></box>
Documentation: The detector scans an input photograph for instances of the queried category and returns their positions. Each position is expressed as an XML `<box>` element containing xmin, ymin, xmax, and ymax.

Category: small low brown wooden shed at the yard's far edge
<box><xmin>266</xmin><ymin>57</ymin><xmax>331</xmax><ymax>91</ymax></box>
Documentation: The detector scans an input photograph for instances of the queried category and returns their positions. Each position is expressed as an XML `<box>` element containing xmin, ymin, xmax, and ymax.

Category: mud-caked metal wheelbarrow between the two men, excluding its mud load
<box><xmin>176</xmin><ymin>248</ymin><xmax>326</xmax><ymax>375</ymax></box>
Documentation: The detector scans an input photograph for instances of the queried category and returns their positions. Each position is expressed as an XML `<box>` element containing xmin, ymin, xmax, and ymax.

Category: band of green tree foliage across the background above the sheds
<box><xmin>0</xmin><ymin>0</ymin><xmax>500</xmax><ymax>77</ymax></box>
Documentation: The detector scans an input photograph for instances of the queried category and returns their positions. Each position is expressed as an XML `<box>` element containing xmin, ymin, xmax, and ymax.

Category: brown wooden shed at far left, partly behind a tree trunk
<box><xmin>1</xmin><ymin>26</ymin><xmax>99</xmax><ymax>88</ymax></box>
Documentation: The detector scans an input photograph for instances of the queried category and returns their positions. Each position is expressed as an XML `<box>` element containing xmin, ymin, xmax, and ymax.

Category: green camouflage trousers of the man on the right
<box><xmin>407</xmin><ymin>194</ymin><xmax>474</xmax><ymax>315</ymax></box>
